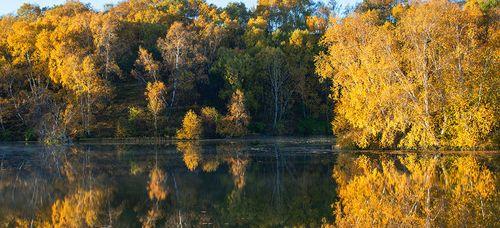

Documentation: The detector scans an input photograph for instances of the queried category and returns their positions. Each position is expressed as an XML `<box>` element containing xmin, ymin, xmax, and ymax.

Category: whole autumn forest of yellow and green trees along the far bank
<box><xmin>0</xmin><ymin>0</ymin><xmax>500</xmax><ymax>148</ymax></box>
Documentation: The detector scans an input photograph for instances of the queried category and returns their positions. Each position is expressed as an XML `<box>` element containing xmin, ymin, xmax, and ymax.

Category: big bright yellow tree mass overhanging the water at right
<box><xmin>316</xmin><ymin>0</ymin><xmax>499</xmax><ymax>148</ymax></box>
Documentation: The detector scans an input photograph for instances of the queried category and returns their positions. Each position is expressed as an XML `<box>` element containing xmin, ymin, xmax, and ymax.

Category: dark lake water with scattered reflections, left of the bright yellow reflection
<box><xmin>0</xmin><ymin>141</ymin><xmax>335</xmax><ymax>227</ymax></box>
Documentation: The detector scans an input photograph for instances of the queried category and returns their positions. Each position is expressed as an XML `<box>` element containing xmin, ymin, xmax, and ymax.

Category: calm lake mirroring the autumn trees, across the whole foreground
<box><xmin>0</xmin><ymin>138</ymin><xmax>500</xmax><ymax>227</ymax></box>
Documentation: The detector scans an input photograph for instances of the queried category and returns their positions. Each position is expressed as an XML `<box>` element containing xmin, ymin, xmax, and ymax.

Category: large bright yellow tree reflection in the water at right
<box><xmin>333</xmin><ymin>154</ymin><xmax>500</xmax><ymax>227</ymax></box>
